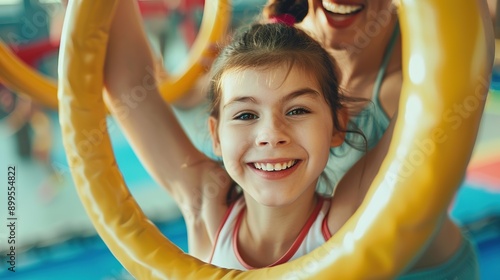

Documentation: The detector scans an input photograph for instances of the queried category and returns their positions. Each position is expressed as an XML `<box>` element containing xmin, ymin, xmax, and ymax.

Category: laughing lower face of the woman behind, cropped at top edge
<box><xmin>301</xmin><ymin>0</ymin><xmax>397</xmax><ymax>52</ymax></box>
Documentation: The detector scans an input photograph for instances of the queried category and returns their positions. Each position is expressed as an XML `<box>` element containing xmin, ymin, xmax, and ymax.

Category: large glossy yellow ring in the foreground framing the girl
<box><xmin>59</xmin><ymin>0</ymin><xmax>492</xmax><ymax>279</ymax></box>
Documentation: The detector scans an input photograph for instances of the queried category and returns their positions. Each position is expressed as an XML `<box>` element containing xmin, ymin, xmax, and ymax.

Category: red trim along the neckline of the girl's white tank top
<box><xmin>233</xmin><ymin>196</ymin><xmax>325</xmax><ymax>270</ymax></box>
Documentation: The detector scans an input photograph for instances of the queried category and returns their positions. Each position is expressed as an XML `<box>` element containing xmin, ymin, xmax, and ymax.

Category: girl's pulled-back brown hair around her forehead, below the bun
<box><xmin>209</xmin><ymin>23</ymin><xmax>347</xmax><ymax>138</ymax></box>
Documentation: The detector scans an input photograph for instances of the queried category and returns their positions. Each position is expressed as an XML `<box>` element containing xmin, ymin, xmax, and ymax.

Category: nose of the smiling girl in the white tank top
<box><xmin>255</xmin><ymin>118</ymin><xmax>290</xmax><ymax>147</ymax></box>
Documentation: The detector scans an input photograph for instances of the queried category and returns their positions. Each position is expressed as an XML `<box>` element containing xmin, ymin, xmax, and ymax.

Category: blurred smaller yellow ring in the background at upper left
<box><xmin>0</xmin><ymin>0</ymin><xmax>231</xmax><ymax>109</ymax></box>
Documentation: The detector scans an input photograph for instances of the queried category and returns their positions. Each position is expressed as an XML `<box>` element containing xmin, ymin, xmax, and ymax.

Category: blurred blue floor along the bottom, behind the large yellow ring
<box><xmin>0</xmin><ymin>210</ymin><xmax>500</xmax><ymax>280</ymax></box>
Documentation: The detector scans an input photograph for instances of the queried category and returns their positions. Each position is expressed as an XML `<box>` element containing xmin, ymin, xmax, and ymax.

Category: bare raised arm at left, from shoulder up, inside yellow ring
<box><xmin>104</xmin><ymin>0</ymin><xmax>230</xmax><ymax>258</ymax></box>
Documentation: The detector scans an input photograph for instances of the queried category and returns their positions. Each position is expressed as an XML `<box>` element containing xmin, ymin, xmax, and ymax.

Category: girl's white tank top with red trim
<box><xmin>209</xmin><ymin>196</ymin><xmax>332</xmax><ymax>270</ymax></box>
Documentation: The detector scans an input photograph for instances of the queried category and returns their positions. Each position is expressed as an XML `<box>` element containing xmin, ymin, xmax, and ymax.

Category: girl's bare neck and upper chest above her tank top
<box><xmin>238</xmin><ymin>190</ymin><xmax>318</xmax><ymax>267</ymax></box>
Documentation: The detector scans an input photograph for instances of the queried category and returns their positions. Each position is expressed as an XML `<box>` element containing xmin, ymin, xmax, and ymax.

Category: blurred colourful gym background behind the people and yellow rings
<box><xmin>0</xmin><ymin>0</ymin><xmax>500</xmax><ymax>280</ymax></box>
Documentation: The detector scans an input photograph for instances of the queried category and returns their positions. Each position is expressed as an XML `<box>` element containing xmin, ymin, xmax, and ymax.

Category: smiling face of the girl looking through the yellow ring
<box><xmin>209</xmin><ymin>67</ymin><xmax>343</xmax><ymax>206</ymax></box>
